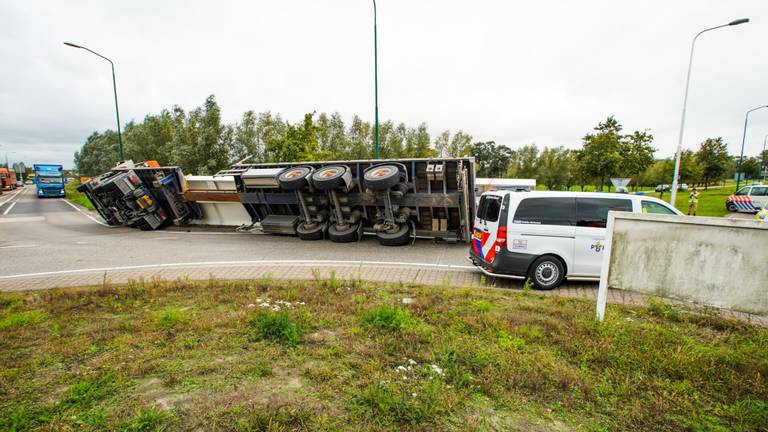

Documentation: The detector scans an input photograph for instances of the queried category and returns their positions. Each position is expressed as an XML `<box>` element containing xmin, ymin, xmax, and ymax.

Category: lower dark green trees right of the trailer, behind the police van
<box><xmin>472</xmin><ymin>116</ymin><xmax>768</xmax><ymax>190</ymax></box>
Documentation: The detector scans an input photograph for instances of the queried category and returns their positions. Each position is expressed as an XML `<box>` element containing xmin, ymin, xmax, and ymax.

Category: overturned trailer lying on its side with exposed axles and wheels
<box><xmin>217</xmin><ymin>158</ymin><xmax>475</xmax><ymax>246</ymax></box>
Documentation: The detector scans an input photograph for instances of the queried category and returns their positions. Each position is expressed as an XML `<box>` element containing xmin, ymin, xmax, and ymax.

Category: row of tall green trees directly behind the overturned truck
<box><xmin>74</xmin><ymin>95</ymin><xmax>472</xmax><ymax>176</ymax></box>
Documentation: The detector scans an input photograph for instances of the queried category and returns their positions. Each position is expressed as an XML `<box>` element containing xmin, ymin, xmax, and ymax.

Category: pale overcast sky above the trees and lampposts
<box><xmin>0</xmin><ymin>0</ymin><xmax>768</xmax><ymax>166</ymax></box>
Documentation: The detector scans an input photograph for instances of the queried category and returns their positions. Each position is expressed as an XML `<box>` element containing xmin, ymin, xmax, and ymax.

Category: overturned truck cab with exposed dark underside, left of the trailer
<box><xmin>77</xmin><ymin>161</ymin><xmax>200</xmax><ymax>230</ymax></box>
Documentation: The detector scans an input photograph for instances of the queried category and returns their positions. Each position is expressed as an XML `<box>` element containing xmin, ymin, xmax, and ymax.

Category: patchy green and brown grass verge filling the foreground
<box><xmin>0</xmin><ymin>277</ymin><xmax>768</xmax><ymax>431</ymax></box>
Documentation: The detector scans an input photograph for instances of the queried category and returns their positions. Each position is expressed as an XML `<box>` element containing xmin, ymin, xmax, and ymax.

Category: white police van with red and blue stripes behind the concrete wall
<box><xmin>469</xmin><ymin>191</ymin><xmax>682</xmax><ymax>289</ymax></box>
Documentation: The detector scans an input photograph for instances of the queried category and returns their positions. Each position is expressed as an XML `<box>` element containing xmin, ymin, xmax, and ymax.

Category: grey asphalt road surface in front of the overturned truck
<box><xmin>0</xmin><ymin>186</ymin><xmax>469</xmax><ymax>276</ymax></box>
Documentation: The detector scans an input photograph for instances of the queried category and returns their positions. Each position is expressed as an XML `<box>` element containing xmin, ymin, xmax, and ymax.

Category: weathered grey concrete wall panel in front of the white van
<box><xmin>606</xmin><ymin>212</ymin><xmax>768</xmax><ymax>315</ymax></box>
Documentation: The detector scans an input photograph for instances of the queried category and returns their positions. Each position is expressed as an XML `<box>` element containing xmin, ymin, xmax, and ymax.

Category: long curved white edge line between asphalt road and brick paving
<box><xmin>0</xmin><ymin>260</ymin><xmax>475</xmax><ymax>280</ymax></box>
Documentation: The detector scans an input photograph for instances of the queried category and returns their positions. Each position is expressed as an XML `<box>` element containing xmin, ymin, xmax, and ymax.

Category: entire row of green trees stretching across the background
<box><xmin>74</xmin><ymin>95</ymin><xmax>768</xmax><ymax>190</ymax></box>
